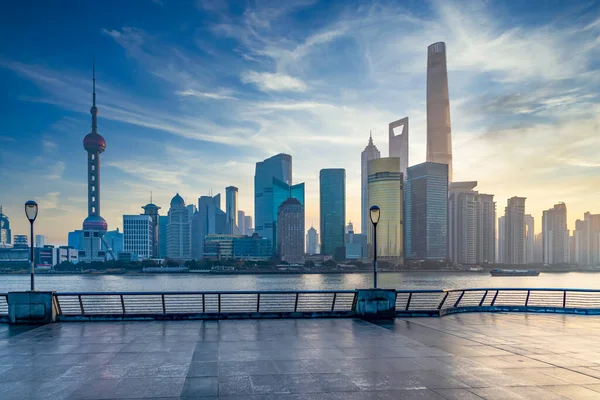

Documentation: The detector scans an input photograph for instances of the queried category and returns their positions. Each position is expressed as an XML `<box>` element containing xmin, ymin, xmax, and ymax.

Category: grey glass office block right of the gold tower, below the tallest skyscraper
<box><xmin>404</xmin><ymin>162</ymin><xmax>448</xmax><ymax>260</ymax></box>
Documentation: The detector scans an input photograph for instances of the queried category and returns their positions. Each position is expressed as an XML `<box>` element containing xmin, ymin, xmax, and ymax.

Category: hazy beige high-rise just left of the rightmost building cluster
<box><xmin>542</xmin><ymin>203</ymin><xmax>570</xmax><ymax>264</ymax></box>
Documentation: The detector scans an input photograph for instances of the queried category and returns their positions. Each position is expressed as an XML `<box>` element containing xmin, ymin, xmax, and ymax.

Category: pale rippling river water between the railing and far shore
<box><xmin>0</xmin><ymin>272</ymin><xmax>600</xmax><ymax>293</ymax></box>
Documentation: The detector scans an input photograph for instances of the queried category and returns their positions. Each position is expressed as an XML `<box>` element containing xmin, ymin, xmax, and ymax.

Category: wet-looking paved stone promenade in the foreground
<box><xmin>0</xmin><ymin>313</ymin><xmax>600</xmax><ymax>400</ymax></box>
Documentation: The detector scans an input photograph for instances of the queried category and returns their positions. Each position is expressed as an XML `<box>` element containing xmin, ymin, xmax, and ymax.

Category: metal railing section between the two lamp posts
<box><xmin>55</xmin><ymin>290</ymin><xmax>356</xmax><ymax>317</ymax></box>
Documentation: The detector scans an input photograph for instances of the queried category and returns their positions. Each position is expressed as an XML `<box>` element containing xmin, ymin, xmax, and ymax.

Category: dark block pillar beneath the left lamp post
<box><xmin>8</xmin><ymin>291</ymin><xmax>56</xmax><ymax>324</ymax></box>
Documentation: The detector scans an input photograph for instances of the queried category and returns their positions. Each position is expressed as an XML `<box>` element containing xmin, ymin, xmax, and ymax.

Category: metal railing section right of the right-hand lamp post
<box><xmin>396</xmin><ymin>288</ymin><xmax>600</xmax><ymax>315</ymax></box>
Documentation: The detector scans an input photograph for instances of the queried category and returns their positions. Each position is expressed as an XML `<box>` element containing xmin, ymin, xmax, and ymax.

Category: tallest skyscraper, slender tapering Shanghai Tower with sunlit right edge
<box><xmin>427</xmin><ymin>42</ymin><xmax>452</xmax><ymax>181</ymax></box>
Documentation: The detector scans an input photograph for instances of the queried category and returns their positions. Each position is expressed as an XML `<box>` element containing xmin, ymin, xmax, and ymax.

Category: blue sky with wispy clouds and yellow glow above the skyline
<box><xmin>0</xmin><ymin>0</ymin><xmax>600</xmax><ymax>244</ymax></box>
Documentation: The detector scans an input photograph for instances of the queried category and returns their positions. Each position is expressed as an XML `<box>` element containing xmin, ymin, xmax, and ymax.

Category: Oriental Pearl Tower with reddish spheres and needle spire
<box><xmin>83</xmin><ymin>64</ymin><xmax>107</xmax><ymax>261</ymax></box>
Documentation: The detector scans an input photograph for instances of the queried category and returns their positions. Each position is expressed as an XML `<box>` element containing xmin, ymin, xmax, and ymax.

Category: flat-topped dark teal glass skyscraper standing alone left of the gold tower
<box><xmin>319</xmin><ymin>168</ymin><xmax>346</xmax><ymax>256</ymax></box>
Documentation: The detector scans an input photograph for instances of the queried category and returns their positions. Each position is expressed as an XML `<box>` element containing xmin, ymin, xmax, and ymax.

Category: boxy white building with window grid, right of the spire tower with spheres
<box><xmin>123</xmin><ymin>215</ymin><xmax>155</xmax><ymax>259</ymax></box>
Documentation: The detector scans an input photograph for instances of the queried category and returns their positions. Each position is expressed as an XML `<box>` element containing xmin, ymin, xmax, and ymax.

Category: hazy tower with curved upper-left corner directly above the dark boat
<box><xmin>504</xmin><ymin>197</ymin><xmax>525</xmax><ymax>265</ymax></box>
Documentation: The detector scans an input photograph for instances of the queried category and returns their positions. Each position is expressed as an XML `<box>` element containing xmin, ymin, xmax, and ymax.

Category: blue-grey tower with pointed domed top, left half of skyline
<box><xmin>167</xmin><ymin>193</ymin><xmax>192</xmax><ymax>260</ymax></box>
